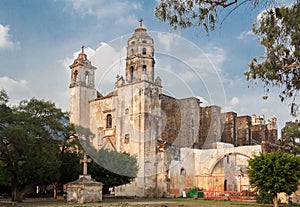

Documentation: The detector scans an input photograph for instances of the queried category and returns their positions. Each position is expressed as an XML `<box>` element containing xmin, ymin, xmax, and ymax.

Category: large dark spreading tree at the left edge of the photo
<box><xmin>0</xmin><ymin>91</ymin><xmax>67</xmax><ymax>201</ymax></box>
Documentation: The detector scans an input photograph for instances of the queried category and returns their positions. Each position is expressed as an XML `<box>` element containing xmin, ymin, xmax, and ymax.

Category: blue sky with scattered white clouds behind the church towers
<box><xmin>0</xmin><ymin>0</ymin><xmax>299</xmax><ymax>133</ymax></box>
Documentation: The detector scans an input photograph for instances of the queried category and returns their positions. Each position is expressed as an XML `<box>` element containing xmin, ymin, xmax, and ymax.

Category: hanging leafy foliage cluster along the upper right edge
<box><xmin>245</xmin><ymin>1</ymin><xmax>300</xmax><ymax>116</ymax></box>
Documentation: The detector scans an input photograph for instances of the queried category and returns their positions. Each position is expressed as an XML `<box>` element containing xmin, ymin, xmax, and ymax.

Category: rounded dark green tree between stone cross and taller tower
<box><xmin>89</xmin><ymin>149</ymin><xmax>138</xmax><ymax>187</ymax></box>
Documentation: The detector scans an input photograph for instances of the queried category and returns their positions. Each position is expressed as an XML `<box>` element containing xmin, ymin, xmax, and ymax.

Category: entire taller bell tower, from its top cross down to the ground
<box><xmin>112</xmin><ymin>19</ymin><xmax>163</xmax><ymax>197</ymax></box>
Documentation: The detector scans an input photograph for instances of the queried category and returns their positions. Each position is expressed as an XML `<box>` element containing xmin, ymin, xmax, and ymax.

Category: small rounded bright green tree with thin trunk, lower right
<box><xmin>248</xmin><ymin>151</ymin><xmax>300</xmax><ymax>207</ymax></box>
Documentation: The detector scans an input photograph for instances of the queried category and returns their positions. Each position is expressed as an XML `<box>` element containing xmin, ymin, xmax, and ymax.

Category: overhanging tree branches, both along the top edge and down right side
<box><xmin>154</xmin><ymin>0</ymin><xmax>300</xmax><ymax>116</ymax></box>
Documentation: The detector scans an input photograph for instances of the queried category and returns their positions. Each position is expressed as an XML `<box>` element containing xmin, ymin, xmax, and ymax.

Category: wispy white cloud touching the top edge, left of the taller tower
<box><xmin>65</xmin><ymin>0</ymin><xmax>142</xmax><ymax>26</ymax></box>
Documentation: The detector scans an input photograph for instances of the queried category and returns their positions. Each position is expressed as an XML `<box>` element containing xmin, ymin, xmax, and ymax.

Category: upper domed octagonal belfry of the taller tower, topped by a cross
<box><xmin>126</xmin><ymin>19</ymin><xmax>155</xmax><ymax>83</ymax></box>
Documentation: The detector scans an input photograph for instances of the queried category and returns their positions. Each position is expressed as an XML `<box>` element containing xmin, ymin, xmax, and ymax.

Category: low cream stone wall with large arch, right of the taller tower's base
<box><xmin>169</xmin><ymin>142</ymin><xmax>261</xmax><ymax>197</ymax></box>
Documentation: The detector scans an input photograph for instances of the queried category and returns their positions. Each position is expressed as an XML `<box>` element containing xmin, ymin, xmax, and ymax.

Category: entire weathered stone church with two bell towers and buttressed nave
<box><xmin>70</xmin><ymin>21</ymin><xmax>277</xmax><ymax>197</ymax></box>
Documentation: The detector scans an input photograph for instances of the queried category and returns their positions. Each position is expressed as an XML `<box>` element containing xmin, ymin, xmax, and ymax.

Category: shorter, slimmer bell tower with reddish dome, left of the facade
<box><xmin>70</xmin><ymin>46</ymin><xmax>97</xmax><ymax>128</ymax></box>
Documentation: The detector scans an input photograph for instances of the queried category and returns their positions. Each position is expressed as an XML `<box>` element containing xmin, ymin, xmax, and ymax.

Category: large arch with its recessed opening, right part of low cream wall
<box><xmin>196</xmin><ymin>143</ymin><xmax>261</xmax><ymax>193</ymax></box>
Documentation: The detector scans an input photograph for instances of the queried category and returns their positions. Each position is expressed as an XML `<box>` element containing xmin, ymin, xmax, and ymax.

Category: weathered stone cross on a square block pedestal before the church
<box><xmin>64</xmin><ymin>153</ymin><xmax>103</xmax><ymax>203</ymax></box>
